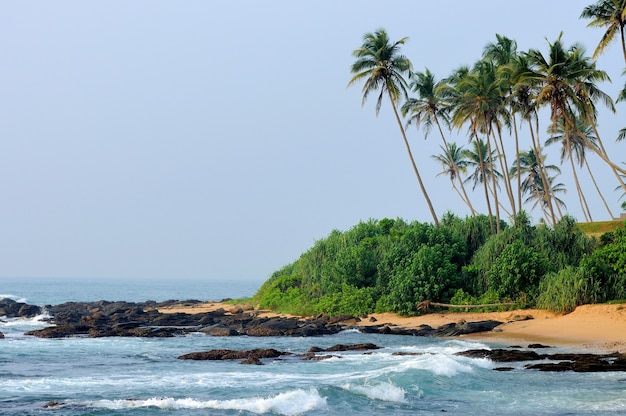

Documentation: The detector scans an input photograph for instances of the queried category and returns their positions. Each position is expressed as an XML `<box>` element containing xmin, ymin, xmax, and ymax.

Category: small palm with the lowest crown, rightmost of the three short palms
<box><xmin>511</xmin><ymin>149</ymin><xmax>563</xmax><ymax>224</ymax></box>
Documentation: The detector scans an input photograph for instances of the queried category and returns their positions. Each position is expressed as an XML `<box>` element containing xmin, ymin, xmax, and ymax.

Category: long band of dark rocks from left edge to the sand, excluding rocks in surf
<box><xmin>0</xmin><ymin>298</ymin><xmax>502</xmax><ymax>338</ymax></box>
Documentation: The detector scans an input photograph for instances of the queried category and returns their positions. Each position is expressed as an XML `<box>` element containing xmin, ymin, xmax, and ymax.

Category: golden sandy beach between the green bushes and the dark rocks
<box><xmin>161</xmin><ymin>302</ymin><xmax>626</xmax><ymax>353</ymax></box>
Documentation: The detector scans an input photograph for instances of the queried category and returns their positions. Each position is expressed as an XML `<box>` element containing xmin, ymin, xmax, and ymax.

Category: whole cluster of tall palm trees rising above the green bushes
<box><xmin>348</xmin><ymin>0</ymin><xmax>626</xmax><ymax>232</ymax></box>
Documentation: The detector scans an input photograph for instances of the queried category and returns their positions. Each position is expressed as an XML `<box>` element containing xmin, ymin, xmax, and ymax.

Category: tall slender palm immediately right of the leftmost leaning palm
<box><xmin>401</xmin><ymin>68</ymin><xmax>476</xmax><ymax>215</ymax></box>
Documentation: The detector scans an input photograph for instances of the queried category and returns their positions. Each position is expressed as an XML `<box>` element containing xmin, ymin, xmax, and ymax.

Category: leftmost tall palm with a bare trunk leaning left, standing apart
<box><xmin>348</xmin><ymin>29</ymin><xmax>439</xmax><ymax>227</ymax></box>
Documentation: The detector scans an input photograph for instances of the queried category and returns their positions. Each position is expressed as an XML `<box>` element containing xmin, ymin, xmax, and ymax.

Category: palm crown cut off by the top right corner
<box><xmin>580</xmin><ymin>0</ymin><xmax>626</xmax><ymax>62</ymax></box>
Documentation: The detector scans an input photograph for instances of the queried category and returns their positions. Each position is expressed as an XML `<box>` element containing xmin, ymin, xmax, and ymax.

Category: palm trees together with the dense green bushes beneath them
<box><xmin>254</xmin><ymin>0</ymin><xmax>626</xmax><ymax>315</ymax></box>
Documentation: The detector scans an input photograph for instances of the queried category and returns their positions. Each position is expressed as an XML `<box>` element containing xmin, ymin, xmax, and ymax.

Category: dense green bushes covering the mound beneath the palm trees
<box><xmin>254</xmin><ymin>212</ymin><xmax>626</xmax><ymax>315</ymax></box>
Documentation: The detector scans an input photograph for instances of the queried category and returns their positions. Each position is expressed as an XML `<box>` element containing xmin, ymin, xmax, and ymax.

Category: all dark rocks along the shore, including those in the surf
<box><xmin>0</xmin><ymin>298</ymin><xmax>626</xmax><ymax>372</ymax></box>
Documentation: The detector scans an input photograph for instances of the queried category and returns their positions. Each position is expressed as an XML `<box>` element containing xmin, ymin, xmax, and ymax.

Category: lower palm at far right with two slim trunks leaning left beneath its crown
<box><xmin>546</xmin><ymin>118</ymin><xmax>613</xmax><ymax>222</ymax></box>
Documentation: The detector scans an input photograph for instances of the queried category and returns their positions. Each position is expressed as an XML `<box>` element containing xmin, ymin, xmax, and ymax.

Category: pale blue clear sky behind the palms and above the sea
<box><xmin>0</xmin><ymin>0</ymin><xmax>626</xmax><ymax>282</ymax></box>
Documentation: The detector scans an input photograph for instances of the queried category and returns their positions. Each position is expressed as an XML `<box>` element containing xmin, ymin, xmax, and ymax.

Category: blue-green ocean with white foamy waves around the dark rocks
<box><xmin>0</xmin><ymin>279</ymin><xmax>626</xmax><ymax>416</ymax></box>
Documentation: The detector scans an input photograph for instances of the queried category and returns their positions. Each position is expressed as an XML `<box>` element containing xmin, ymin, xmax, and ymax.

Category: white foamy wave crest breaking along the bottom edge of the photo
<box><xmin>91</xmin><ymin>389</ymin><xmax>326</xmax><ymax>416</ymax></box>
